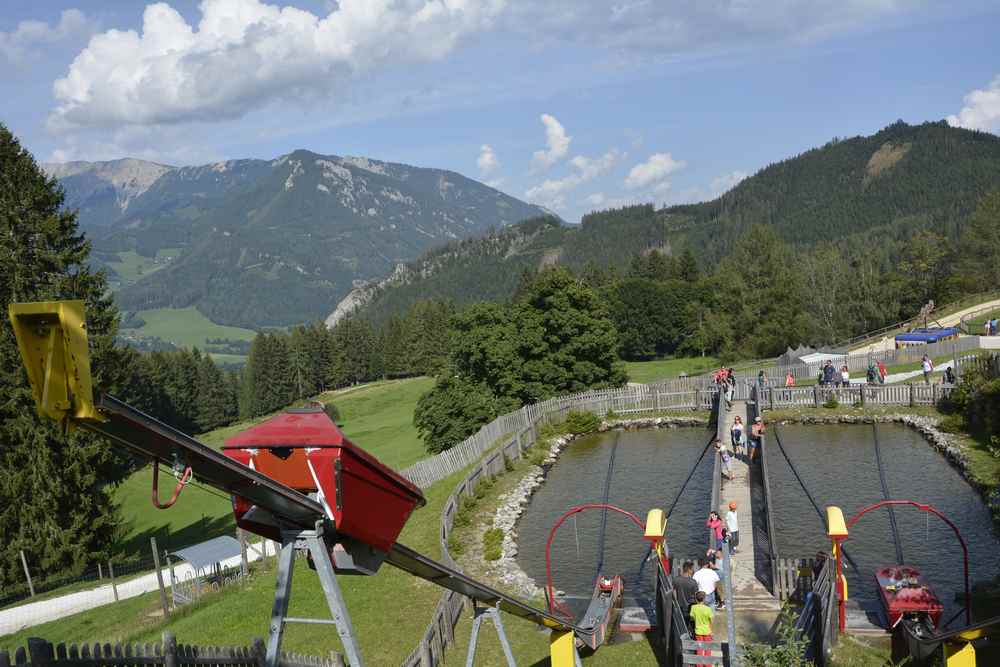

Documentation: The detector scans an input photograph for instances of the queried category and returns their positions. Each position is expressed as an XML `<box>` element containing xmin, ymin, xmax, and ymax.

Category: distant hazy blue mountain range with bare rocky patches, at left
<box><xmin>43</xmin><ymin>150</ymin><xmax>545</xmax><ymax>328</ymax></box>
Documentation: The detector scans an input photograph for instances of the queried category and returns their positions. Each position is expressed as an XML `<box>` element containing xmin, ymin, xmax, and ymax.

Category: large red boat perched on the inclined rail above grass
<box><xmin>222</xmin><ymin>407</ymin><xmax>425</xmax><ymax>573</ymax></box>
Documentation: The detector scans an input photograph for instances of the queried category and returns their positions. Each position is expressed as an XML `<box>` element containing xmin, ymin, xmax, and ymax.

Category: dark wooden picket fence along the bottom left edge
<box><xmin>0</xmin><ymin>632</ymin><xmax>345</xmax><ymax>667</ymax></box>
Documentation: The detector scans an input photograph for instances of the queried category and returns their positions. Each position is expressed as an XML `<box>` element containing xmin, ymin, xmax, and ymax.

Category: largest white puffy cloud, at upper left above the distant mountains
<box><xmin>50</xmin><ymin>0</ymin><xmax>506</xmax><ymax>129</ymax></box>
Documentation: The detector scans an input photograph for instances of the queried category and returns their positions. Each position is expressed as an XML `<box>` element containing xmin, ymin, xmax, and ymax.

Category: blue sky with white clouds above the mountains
<box><xmin>0</xmin><ymin>0</ymin><xmax>1000</xmax><ymax>220</ymax></box>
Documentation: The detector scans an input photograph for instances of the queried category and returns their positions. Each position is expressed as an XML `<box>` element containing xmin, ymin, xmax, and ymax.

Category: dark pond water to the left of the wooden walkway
<box><xmin>517</xmin><ymin>428</ymin><xmax>714</xmax><ymax>607</ymax></box>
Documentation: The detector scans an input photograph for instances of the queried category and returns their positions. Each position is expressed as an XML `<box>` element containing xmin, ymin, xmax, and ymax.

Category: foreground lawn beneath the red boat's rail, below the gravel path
<box><xmin>0</xmin><ymin>472</ymin><xmax>464</xmax><ymax>665</ymax></box>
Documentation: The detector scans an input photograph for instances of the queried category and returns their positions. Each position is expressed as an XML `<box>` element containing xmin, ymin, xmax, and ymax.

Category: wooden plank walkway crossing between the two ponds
<box><xmin>719</xmin><ymin>401</ymin><xmax>781</xmax><ymax>618</ymax></box>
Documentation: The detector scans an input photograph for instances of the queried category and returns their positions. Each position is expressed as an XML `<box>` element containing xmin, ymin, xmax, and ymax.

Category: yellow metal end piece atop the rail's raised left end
<box><xmin>8</xmin><ymin>301</ymin><xmax>103</xmax><ymax>424</ymax></box>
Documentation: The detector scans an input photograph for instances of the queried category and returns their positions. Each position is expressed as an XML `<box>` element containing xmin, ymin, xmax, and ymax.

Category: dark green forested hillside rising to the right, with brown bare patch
<box><xmin>344</xmin><ymin>122</ymin><xmax>1000</xmax><ymax>328</ymax></box>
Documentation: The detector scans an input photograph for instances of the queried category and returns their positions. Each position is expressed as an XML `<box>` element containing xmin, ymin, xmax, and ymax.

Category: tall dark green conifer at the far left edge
<box><xmin>0</xmin><ymin>125</ymin><xmax>129</xmax><ymax>586</ymax></box>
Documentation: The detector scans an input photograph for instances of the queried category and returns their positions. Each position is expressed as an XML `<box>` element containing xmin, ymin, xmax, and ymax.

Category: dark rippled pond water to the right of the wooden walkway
<box><xmin>767</xmin><ymin>424</ymin><xmax>1000</xmax><ymax>619</ymax></box>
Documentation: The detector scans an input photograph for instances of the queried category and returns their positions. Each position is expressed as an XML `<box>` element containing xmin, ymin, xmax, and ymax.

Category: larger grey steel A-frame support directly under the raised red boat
<box><xmin>264</xmin><ymin>524</ymin><xmax>364</xmax><ymax>667</ymax></box>
